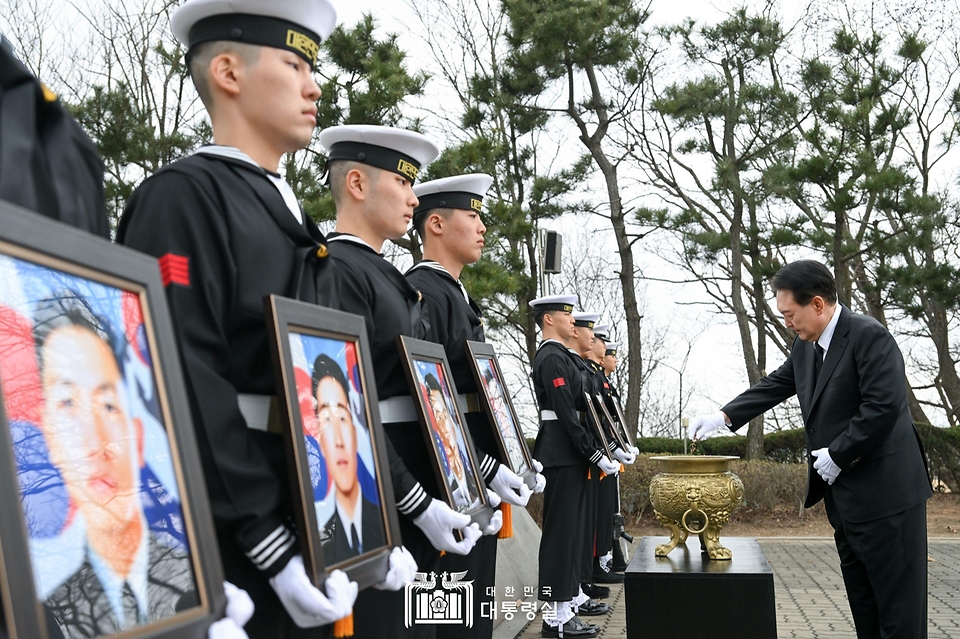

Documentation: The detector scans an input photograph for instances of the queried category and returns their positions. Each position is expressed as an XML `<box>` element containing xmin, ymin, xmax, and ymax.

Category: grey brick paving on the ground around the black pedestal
<box><xmin>517</xmin><ymin>537</ymin><xmax>960</xmax><ymax>639</ymax></box>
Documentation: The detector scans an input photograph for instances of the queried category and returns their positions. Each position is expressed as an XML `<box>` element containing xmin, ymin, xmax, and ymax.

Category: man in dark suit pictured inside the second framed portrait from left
<box><xmin>312</xmin><ymin>354</ymin><xmax>386</xmax><ymax>566</ymax></box>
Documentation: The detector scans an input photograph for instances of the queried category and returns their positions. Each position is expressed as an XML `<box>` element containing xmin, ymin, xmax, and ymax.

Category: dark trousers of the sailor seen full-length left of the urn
<box><xmin>538</xmin><ymin>463</ymin><xmax>587</xmax><ymax>601</ymax></box>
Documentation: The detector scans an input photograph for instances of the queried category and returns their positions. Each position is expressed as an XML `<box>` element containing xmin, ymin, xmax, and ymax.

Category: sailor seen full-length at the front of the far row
<box><xmin>530</xmin><ymin>295</ymin><xmax>618</xmax><ymax>637</ymax></box>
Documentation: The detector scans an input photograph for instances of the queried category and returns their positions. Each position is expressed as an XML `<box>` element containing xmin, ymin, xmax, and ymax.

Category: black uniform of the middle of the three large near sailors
<box><xmin>327</xmin><ymin>233</ymin><xmax>441</xmax><ymax>639</ymax></box>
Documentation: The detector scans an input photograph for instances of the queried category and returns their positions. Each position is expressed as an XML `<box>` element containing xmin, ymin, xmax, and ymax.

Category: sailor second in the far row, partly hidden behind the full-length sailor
<box><xmin>585</xmin><ymin>324</ymin><xmax>636</xmax><ymax>594</ymax></box>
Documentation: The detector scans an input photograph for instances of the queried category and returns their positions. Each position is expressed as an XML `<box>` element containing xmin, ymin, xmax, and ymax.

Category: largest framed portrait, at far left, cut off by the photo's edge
<box><xmin>0</xmin><ymin>203</ymin><xmax>225</xmax><ymax>639</ymax></box>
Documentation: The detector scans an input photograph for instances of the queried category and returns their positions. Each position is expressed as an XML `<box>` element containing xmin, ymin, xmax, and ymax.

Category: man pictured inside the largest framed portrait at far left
<box><xmin>34</xmin><ymin>291</ymin><xmax>195</xmax><ymax>638</ymax></box>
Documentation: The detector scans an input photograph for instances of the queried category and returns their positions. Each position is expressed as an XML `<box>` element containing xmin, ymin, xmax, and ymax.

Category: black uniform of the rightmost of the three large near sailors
<box><xmin>406</xmin><ymin>260</ymin><xmax>506</xmax><ymax>639</ymax></box>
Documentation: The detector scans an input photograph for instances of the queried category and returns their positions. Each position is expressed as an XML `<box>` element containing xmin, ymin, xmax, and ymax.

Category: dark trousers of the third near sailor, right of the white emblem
<box><xmin>437</xmin><ymin>535</ymin><xmax>497</xmax><ymax>639</ymax></box>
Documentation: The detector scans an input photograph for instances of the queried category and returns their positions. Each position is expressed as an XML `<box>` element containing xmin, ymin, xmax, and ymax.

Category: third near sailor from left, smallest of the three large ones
<box><xmin>406</xmin><ymin>173</ymin><xmax>532</xmax><ymax>639</ymax></box>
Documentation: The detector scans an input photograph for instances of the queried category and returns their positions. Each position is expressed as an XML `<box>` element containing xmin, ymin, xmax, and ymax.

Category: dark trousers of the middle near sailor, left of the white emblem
<box><xmin>353</xmin><ymin>515</ymin><xmax>440</xmax><ymax>639</ymax></box>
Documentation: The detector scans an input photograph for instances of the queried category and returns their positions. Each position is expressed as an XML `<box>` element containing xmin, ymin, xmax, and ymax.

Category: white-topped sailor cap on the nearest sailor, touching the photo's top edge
<box><xmin>170</xmin><ymin>0</ymin><xmax>337</xmax><ymax>68</ymax></box>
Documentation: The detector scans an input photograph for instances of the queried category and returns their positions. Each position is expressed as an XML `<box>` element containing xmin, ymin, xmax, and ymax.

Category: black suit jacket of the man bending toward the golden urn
<box><xmin>722</xmin><ymin>306</ymin><xmax>932</xmax><ymax>522</ymax></box>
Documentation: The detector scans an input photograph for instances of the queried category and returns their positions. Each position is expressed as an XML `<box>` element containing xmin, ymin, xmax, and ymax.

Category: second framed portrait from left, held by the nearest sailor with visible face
<box><xmin>265</xmin><ymin>295</ymin><xmax>401</xmax><ymax>588</ymax></box>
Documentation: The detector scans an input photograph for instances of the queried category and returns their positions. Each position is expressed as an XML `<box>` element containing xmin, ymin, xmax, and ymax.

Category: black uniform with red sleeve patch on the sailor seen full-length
<box><xmin>533</xmin><ymin>339</ymin><xmax>602</xmax><ymax>602</ymax></box>
